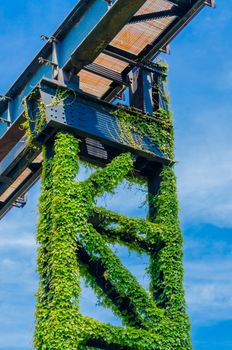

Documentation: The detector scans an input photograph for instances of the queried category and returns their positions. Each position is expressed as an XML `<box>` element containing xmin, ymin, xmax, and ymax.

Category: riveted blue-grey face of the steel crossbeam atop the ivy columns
<box><xmin>38</xmin><ymin>82</ymin><xmax>165</xmax><ymax>159</ymax></box>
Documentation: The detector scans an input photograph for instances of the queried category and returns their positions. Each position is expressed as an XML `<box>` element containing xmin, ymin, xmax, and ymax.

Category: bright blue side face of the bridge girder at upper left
<box><xmin>0</xmin><ymin>0</ymin><xmax>115</xmax><ymax>137</ymax></box>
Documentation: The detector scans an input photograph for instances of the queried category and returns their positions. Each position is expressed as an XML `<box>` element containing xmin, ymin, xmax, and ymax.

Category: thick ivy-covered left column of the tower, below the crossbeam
<box><xmin>34</xmin><ymin>133</ymin><xmax>80</xmax><ymax>350</ymax></box>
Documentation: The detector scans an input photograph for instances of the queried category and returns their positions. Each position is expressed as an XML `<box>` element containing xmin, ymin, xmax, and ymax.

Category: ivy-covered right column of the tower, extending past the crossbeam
<box><xmin>148</xmin><ymin>69</ymin><xmax>191</xmax><ymax>350</ymax></box>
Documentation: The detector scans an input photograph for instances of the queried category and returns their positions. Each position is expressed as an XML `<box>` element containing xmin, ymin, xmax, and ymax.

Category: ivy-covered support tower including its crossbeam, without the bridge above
<box><xmin>24</xmin><ymin>63</ymin><xmax>191</xmax><ymax>350</ymax></box>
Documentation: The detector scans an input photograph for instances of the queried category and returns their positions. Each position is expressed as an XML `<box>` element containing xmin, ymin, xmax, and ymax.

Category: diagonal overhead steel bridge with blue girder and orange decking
<box><xmin>0</xmin><ymin>0</ymin><xmax>214</xmax><ymax>217</ymax></box>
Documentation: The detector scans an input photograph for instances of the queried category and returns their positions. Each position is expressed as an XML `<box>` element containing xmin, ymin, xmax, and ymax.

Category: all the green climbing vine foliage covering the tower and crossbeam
<box><xmin>30</xmin><ymin>62</ymin><xmax>191</xmax><ymax>350</ymax></box>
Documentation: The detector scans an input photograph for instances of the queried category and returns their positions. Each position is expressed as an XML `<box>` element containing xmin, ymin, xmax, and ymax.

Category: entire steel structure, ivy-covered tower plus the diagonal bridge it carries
<box><xmin>0</xmin><ymin>0</ymin><xmax>214</xmax><ymax>350</ymax></box>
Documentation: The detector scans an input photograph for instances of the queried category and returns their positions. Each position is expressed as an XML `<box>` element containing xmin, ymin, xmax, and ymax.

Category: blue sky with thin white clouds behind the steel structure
<box><xmin>0</xmin><ymin>0</ymin><xmax>232</xmax><ymax>350</ymax></box>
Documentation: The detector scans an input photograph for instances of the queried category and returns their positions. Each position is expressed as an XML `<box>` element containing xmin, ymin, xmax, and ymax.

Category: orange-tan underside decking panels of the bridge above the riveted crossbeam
<box><xmin>76</xmin><ymin>0</ymin><xmax>176</xmax><ymax>98</ymax></box>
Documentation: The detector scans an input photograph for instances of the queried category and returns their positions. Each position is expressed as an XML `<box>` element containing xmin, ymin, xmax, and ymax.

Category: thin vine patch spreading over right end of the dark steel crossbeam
<box><xmin>113</xmin><ymin>64</ymin><xmax>174</xmax><ymax>160</ymax></box>
